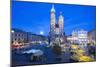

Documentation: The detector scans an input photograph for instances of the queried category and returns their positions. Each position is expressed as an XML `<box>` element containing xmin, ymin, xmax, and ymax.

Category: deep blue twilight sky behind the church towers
<box><xmin>11</xmin><ymin>1</ymin><xmax>96</xmax><ymax>35</ymax></box>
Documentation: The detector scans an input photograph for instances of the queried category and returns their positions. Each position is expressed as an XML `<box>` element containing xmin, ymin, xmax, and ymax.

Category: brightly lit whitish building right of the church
<box><xmin>67</xmin><ymin>30</ymin><xmax>88</xmax><ymax>44</ymax></box>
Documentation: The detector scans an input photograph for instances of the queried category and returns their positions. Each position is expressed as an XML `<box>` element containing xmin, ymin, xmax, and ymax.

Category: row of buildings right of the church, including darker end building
<box><xmin>67</xmin><ymin>30</ymin><xmax>96</xmax><ymax>44</ymax></box>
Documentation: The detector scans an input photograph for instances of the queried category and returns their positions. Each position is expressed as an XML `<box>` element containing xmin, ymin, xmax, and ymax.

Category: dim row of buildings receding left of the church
<box><xmin>11</xmin><ymin>28</ymin><xmax>46</xmax><ymax>43</ymax></box>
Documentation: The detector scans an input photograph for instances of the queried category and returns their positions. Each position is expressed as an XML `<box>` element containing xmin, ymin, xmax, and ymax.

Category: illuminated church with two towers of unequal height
<box><xmin>50</xmin><ymin>5</ymin><xmax>64</xmax><ymax>45</ymax></box>
